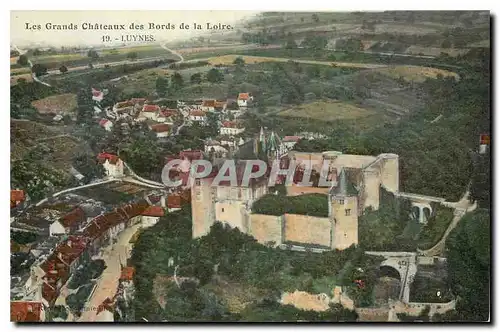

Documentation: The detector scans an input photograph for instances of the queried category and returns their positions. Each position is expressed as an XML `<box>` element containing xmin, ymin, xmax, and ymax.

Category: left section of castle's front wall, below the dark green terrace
<box><xmin>249</xmin><ymin>214</ymin><xmax>282</xmax><ymax>245</ymax></box>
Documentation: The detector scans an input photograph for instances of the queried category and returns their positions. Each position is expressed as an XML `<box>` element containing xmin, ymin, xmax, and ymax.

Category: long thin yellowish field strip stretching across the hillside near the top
<box><xmin>207</xmin><ymin>54</ymin><xmax>387</xmax><ymax>69</ymax></box>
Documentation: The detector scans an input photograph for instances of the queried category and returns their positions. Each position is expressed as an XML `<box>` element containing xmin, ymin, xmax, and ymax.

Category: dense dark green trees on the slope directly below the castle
<box><xmin>132</xmin><ymin>206</ymin><xmax>378</xmax><ymax>321</ymax></box>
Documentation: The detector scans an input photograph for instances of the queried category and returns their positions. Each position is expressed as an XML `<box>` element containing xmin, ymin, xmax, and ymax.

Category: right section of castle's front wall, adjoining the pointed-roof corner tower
<box><xmin>284</xmin><ymin>214</ymin><xmax>332</xmax><ymax>248</ymax></box>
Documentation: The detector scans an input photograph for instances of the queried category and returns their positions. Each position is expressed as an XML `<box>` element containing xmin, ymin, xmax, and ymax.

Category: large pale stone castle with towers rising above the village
<box><xmin>191</xmin><ymin>151</ymin><xmax>399</xmax><ymax>249</ymax></box>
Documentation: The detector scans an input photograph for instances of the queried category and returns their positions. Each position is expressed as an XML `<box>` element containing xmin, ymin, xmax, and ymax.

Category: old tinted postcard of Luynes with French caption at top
<box><xmin>10</xmin><ymin>10</ymin><xmax>492</xmax><ymax>324</ymax></box>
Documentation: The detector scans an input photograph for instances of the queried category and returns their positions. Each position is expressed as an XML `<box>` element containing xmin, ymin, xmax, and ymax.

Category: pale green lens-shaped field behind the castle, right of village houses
<box><xmin>278</xmin><ymin>100</ymin><xmax>375</xmax><ymax>121</ymax></box>
